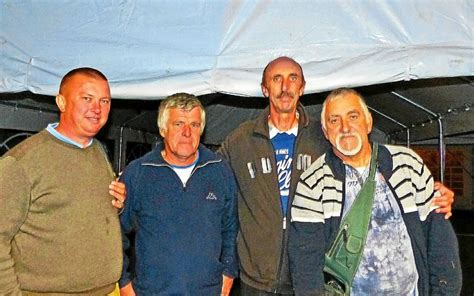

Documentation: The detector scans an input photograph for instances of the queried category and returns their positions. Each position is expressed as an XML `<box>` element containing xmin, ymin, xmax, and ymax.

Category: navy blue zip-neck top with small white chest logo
<box><xmin>120</xmin><ymin>144</ymin><xmax>238</xmax><ymax>296</ymax></box>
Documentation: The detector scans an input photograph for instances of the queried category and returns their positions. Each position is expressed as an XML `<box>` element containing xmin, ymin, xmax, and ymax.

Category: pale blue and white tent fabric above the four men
<box><xmin>0</xmin><ymin>0</ymin><xmax>474</xmax><ymax>99</ymax></box>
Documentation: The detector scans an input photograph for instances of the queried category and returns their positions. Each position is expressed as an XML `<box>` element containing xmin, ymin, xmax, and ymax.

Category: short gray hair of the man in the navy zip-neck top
<box><xmin>157</xmin><ymin>93</ymin><xmax>206</xmax><ymax>134</ymax></box>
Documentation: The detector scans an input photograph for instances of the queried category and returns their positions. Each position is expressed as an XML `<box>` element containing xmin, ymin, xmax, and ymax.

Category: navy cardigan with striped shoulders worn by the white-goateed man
<box><xmin>289</xmin><ymin>145</ymin><xmax>462</xmax><ymax>296</ymax></box>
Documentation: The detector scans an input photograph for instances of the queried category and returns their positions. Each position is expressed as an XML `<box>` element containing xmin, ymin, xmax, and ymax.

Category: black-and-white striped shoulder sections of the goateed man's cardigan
<box><xmin>291</xmin><ymin>145</ymin><xmax>434</xmax><ymax>223</ymax></box>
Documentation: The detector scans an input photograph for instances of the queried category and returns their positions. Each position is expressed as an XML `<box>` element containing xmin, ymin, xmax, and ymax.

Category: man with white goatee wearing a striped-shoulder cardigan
<box><xmin>289</xmin><ymin>88</ymin><xmax>462</xmax><ymax>295</ymax></box>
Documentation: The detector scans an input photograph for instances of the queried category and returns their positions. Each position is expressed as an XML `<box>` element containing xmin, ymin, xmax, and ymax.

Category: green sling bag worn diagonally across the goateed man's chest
<box><xmin>324</xmin><ymin>143</ymin><xmax>378</xmax><ymax>295</ymax></box>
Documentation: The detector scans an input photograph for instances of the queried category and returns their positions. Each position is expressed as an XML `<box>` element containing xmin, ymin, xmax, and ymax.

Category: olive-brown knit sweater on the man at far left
<box><xmin>0</xmin><ymin>130</ymin><xmax>122</xmax><ymax>295</ymax></box>
